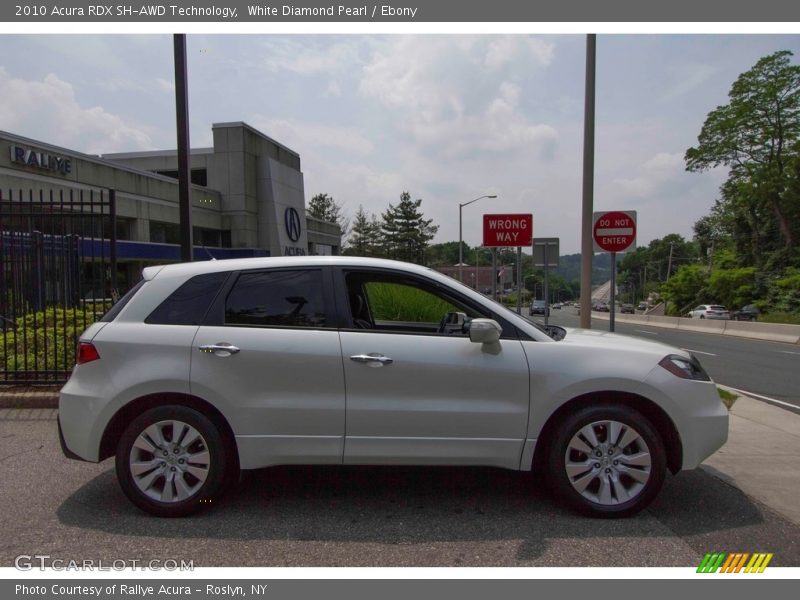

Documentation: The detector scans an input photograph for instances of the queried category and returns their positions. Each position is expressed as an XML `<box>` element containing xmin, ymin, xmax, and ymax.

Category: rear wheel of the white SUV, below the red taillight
<box><xmin>116</xmin><ymin>406</ymin><xmax>232</xmax><ymax>517</ymax></box>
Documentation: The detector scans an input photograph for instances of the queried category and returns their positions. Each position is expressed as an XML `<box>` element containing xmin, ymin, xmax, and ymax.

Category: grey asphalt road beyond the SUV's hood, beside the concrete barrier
<box><xmin>536</xmin><ymin>307</ymin><xmax>800</xmax><ymax>410</ymax></box>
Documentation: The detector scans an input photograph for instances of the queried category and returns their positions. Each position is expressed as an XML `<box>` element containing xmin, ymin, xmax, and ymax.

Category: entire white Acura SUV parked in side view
<box><xmin>58</xmin><ymin>257</ymin><xmax>728</xmax><ymax>517</ymax></box>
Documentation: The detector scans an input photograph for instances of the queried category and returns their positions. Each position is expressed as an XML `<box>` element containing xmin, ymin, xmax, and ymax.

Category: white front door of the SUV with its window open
<box><xmin>340</xmin><ymin>271</ymin><xmax>530</xmax><ymax>469</ymax></box>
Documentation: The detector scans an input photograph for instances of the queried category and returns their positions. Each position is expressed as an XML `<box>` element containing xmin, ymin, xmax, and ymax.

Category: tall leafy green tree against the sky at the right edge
<box><xmin>685</xmin><ymin>50</ymin><xmax>800</xmax><ymax>255</ymax></box>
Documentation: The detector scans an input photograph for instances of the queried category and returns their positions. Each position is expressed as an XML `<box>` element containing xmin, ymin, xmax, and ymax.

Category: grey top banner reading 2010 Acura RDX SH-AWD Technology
<box><xmin>0</xmin><ymin>0</ymin><xmax>800</xmax><ymax>22</ymax></box>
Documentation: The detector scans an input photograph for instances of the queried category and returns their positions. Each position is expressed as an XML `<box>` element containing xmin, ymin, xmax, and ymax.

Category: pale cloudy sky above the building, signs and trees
<box><xmin>0</xmin><ymin>33</ymin><xmax>800</xmax><ymax>254</ymax></box>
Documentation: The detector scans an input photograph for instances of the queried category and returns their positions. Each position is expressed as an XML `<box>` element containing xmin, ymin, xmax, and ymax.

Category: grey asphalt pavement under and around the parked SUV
<box><xmin>0</xmin><ymin>409</ymin><xmax>800</xmax><ymax>567</ymax></box>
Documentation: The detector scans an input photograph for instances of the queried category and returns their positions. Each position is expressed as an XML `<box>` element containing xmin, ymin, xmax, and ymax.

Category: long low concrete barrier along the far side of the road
<box><xmin>592</xmin><ymin>312</ymin><xmax>800</xmax><ymax>344</ymax></box>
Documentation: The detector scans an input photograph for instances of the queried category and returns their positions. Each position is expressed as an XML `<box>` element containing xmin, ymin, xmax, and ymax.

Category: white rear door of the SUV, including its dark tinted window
<box><xmin>191</xmin><ymin>268</ymin><xmax>345</xmax><ymax>468</ymax></box>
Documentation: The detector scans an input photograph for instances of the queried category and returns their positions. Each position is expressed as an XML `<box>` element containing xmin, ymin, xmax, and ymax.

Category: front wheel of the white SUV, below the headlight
<box><xmin>547</xmin><ymin>406</ymin><xmax>667</xmax><ymax>518</ymax></box>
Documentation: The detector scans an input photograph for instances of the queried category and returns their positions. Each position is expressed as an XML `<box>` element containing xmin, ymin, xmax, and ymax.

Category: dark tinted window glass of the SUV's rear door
<box><xmin>225</xmin><ymin>270</ymin><xmax>331</xmax><ymax>328</ymax></box>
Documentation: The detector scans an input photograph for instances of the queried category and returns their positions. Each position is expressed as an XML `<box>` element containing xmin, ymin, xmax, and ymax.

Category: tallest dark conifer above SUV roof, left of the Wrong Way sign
<box><xmin>381</xmin><ymin>192</ymin><xmax>439</xmax><ymax>264</ymax></box>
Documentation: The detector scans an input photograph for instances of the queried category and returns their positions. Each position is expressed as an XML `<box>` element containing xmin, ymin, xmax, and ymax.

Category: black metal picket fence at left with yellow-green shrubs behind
<box><xmin>0</xmin><ymin>189</ymin><xmax>117</xmax><ymax>384</ymax></box>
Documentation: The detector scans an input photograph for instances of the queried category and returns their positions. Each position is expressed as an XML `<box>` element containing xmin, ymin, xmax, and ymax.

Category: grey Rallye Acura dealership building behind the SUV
<box><xmin>0</xmin><ymin>122</ymin><xmax>342</xmax><ymax>288</ymax></box>
